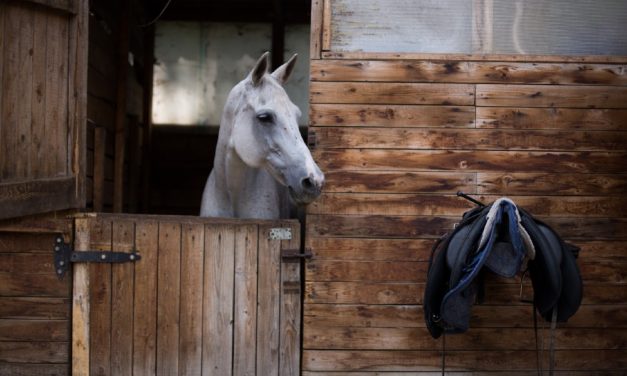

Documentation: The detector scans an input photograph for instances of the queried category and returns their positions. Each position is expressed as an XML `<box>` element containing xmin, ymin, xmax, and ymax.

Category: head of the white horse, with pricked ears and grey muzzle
<box><xmin>223</xmin><ymin>52</ymin><xmax>324</xmax><ymax>209</ymax></box>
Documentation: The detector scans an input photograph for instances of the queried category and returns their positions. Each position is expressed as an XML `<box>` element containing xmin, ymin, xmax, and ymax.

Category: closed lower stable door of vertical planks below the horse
<box><xmin>73</xmin><ymin>214</ymin><xmax>301</xmax><ymax>376</ymax></box>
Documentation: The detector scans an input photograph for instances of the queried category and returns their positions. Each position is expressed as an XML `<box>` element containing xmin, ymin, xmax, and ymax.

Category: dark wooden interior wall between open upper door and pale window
<box><xmin>86</xmin><ymin>1</ymin><xmax>153</xmax><ymax>212</ymax></box>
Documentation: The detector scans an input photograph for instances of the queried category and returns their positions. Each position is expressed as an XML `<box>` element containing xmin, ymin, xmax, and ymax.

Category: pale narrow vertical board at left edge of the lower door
<box><xmin>72</xmin><ymin>218</ymin><xmax>90</xmax><ymax>376</ymax></box>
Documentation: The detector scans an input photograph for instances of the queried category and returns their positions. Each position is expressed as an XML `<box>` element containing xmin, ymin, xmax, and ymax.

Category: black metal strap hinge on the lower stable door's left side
<box><xmin>53</xmin><ymin>236</ymin><xmax>141</xmax><ymax>279</ymax></box>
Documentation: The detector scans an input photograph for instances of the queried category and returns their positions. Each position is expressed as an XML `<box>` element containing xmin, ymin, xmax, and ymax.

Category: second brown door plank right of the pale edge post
<box><xmin>111</xmin><ymin>220</ymin><xmax>135</xmax><ymax>375</ymax></box>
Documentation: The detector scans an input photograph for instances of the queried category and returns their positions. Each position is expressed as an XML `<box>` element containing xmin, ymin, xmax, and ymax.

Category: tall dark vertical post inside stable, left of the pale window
<box><xmin>113</xmin><ymin>1</ymin><xmax>132</xmax><ymax>213</ymax></box>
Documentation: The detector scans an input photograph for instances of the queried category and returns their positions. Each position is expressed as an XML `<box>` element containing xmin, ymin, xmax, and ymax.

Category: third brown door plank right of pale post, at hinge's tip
<box><xmin>133</xmin><ymin>219</ymin><xmax>159</xmax><ymax>375</ymax></box>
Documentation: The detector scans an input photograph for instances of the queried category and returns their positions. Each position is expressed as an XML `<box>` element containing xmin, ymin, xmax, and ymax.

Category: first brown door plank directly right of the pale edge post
<box><xmin>89</xmin><ymin>219</ymin><xmax>113</xmax><ymax>375</ymax></box>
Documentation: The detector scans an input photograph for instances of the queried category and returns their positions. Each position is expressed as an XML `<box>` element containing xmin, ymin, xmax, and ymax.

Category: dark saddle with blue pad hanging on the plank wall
<box><xmin>424</xmin><ymin>193</ymin><xmax>583</xmax><ymax>338</ymax></box>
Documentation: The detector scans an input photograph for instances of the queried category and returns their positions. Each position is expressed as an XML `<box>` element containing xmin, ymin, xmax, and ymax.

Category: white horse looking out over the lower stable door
<box><xmin>200</xmin><ymin>52</ymin><xmax>324</xmax><ymax>219</ymax></box>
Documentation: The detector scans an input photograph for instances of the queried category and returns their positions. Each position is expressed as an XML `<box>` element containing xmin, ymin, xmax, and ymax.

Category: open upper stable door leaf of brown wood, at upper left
<box><xmin>0</xmin><ymin>1</ymin><xmax>88</xmax><ymax>219</ymax></box>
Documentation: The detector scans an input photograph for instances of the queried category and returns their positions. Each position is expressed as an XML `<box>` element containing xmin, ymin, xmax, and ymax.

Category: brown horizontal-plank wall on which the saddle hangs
<box><xmin>303</xmin><ymin>0</ymin><xmax>627</xmax><ymax>376</ymax></box>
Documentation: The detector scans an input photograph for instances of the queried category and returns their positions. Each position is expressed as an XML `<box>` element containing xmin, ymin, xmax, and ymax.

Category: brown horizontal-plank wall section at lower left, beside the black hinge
<box><xmin>0</xmin><ymin>213</ymin><xmax>71</xmax><ymax>376</ymax></box>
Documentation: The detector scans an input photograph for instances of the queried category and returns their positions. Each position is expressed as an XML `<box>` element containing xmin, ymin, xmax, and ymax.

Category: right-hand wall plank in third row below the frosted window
<box><xmin>476</xmin><ymin>107</ymin><xmax>627</xmax><ymax>131</ymax></box>
